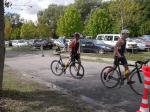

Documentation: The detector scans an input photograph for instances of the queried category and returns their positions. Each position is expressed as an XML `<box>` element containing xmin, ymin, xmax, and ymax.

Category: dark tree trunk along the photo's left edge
<box><xmin>0</xmin><ymin>0</ymin><xmax>5</xmax><ymax>91</ymax></box>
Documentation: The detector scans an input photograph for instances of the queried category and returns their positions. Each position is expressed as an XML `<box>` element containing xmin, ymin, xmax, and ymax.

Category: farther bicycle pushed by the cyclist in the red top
<box><xmin>50</xmin><ymin>53</ymin><xmax>84</xmax><ymax>79</ymax></box>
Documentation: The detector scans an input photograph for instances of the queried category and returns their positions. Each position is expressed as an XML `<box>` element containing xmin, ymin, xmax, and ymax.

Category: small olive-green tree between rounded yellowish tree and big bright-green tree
<box><xmin>37</xmin><ymin>24</ymin><xmax>51</xmax><ymax>38</ymax></box>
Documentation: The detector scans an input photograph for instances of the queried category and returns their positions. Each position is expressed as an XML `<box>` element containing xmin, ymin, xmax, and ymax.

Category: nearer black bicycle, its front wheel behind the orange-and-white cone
<box><xmin>100</xmin><ymin>59</ymin><xmax>150</xmax><ymax>95</ymax></box>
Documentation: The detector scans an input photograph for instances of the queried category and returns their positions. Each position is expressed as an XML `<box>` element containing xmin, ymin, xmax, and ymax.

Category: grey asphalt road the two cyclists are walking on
<box><xmin>5</xmin><ymin>52</ymin><xmax>141</xmax><ymax>112</ymax></box>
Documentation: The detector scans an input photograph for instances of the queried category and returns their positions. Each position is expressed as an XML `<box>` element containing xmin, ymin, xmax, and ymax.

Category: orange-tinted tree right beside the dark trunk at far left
<box><xmin>5</xmin><ymin>19</ymin><xmax>12</xmax><ymax>40</ymax></box>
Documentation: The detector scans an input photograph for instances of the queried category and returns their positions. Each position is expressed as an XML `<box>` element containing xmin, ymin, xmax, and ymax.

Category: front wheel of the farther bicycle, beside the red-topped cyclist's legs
<box><xmin>69</xmin><ymin>62</ymin><xmax>84</xmax><ymax>79</ymax></box>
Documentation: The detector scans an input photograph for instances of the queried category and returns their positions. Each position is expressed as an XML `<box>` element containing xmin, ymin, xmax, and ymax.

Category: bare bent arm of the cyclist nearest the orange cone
<box><xmin>114</xmin><ymin>39</ymin><xmax>124</xmax><ymax>58</ymax></box>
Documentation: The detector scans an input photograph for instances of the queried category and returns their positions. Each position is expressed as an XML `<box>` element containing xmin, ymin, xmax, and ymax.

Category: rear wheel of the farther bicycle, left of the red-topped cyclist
<box><xmin>50</xmin><ymin>60</ymin><xmax>63</xmax><ymax>76</ymax></box>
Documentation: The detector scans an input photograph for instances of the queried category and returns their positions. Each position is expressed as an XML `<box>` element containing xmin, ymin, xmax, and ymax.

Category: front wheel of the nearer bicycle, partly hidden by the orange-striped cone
<box><xmin>129</xmin><ymin>70</ymin><xmax>144</xmax><ymax>96</ymax></box>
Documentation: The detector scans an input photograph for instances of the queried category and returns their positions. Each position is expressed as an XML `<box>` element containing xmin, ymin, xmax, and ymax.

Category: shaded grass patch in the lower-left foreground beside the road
<box><xmin>0</xmin><ymin>67</ymin><xmax>93</xmax><ymax>112</ymax></box>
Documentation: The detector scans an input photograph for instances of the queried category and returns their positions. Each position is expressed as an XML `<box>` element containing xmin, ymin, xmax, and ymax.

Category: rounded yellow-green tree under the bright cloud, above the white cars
<box><xmin>20</xmin><ymin>21</ymin><xmax>36</xmax><ymax>39</ymax></box>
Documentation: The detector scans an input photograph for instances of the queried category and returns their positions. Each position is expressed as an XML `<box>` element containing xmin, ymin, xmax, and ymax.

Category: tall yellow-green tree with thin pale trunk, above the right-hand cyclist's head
<box><xmin>108</xmin><ymin>0</ymin><xmax>141</xmax><ymax>35</ymax></box>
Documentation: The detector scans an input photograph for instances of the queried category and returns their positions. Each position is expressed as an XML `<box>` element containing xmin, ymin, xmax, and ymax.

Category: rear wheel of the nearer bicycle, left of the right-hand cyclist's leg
<box><xmin>100</xmin><ymin>66</ymin><xmax>120</xmax><ymax>88</ymax></box>
